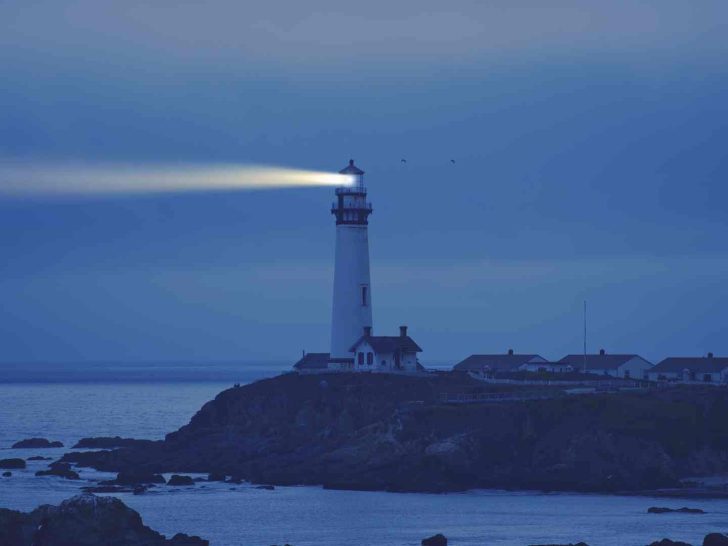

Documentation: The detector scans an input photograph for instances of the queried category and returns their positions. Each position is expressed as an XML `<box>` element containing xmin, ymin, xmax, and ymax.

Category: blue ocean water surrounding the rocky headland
<box><xmin>0</xmin><ymin>363</ymin><xmax>728</xmax><ymax>546</ymax></box>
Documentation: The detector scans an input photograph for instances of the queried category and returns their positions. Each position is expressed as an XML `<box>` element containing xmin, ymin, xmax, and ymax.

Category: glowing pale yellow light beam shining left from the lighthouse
<box><xmin>0</xmin><ymin>161</ymin><xmax>355</xmax><ymax>197</ymax></box>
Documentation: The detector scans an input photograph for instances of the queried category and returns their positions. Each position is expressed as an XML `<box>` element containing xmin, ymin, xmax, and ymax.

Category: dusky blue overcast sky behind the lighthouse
<box><xmin>0</xmin><ymin>0</ymin><xmax>728</xmax><ymax>363</ymax></box>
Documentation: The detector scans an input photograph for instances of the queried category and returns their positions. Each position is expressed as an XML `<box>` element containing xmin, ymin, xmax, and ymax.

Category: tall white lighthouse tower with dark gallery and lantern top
<box><xmin>329</xmin><ymin>159</ymin><xmax>372</xmax><ymax>369</ymax></box>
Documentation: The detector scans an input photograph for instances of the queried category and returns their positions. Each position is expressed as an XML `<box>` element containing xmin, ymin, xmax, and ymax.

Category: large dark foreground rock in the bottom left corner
<box><xmin>0</xmin><ymin>493</ymin><xmax>209</xmax><ymax>546</ymax></box>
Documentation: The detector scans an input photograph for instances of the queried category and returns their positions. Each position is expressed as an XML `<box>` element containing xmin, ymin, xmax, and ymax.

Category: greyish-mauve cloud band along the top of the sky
<box><xmin>0</xmin><ymin>0</ymin><xmax>728</xmax><ymax>72</ymax></box>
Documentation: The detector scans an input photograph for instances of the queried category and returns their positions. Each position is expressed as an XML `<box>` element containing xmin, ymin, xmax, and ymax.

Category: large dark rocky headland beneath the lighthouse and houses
<box><xmin>63</xmin><ymin>374</ymin><xmax>728</xmax><ymax>492</ymax></box>
